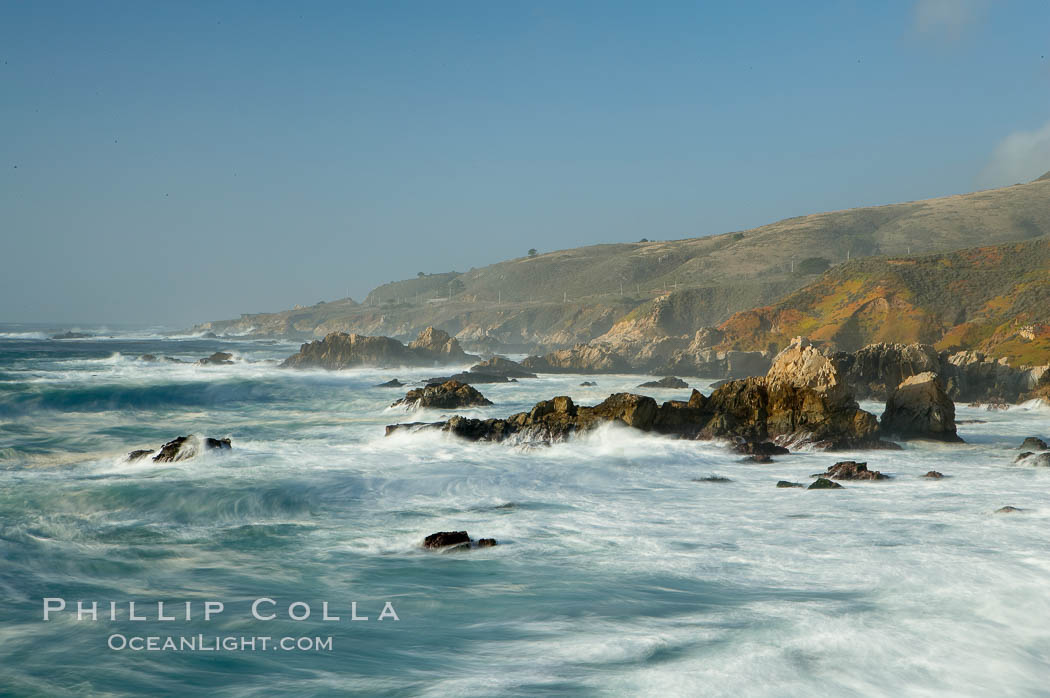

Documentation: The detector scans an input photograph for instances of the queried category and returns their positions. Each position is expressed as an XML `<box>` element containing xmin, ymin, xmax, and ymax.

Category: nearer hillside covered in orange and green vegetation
<box><xmin>720</xmin><ymin>237</ymin><xmax>1050</xmax><ymax>364</ymax></box>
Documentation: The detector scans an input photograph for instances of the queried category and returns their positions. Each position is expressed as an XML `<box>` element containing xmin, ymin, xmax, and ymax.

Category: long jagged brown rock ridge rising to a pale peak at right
<box><xmin>386</xmin><ymin>340</ymin><xmax>886</xmax><ymax>448</ymax></box>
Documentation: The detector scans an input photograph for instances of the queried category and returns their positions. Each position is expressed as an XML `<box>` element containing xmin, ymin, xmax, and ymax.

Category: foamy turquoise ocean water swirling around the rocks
<box><xmin>0</xmin><ymin>326</ymin><xmax>1050</xmax><ymax>696</ymax></box>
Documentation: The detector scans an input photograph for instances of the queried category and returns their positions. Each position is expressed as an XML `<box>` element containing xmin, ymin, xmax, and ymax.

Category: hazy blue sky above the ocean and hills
<box><xmin>0</xmin><ymin>0</ymin><xmax>1050</xmax><ymax>325</ymax></box>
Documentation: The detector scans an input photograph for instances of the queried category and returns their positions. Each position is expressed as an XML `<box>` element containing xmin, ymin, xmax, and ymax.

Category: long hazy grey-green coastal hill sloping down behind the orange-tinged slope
<box><xmin>194</xmin><ymin>176</ymin><xmax>1050</xmax><ymax>351</ymax></box>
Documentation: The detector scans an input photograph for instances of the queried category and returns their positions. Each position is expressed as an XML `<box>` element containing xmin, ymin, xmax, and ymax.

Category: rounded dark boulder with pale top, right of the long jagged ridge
<box><xmin>882</xmin><ymin>372</ymin><xmax>962</xmax><ymax>443</ymax></box>
